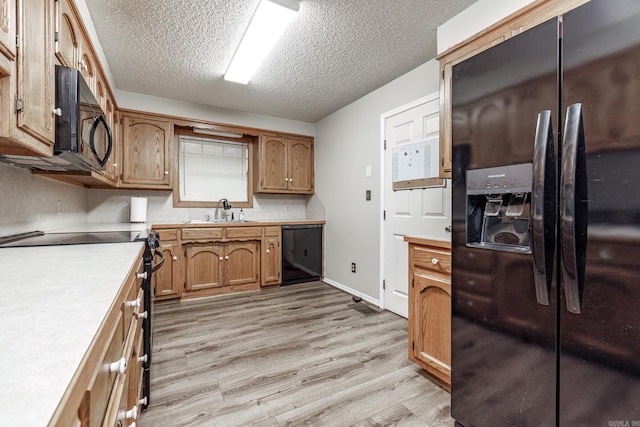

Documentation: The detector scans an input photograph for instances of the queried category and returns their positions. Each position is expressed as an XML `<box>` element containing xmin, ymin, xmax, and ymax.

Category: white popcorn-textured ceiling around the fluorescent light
<box><xmin>86</xmin><ymin>0</ymin><xmax>476</xmax><ymax>123</ymax></box>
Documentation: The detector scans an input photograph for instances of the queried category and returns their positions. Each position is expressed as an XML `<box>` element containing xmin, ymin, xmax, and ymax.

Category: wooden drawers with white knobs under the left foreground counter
<box><xmin>49</xmin><ymin>251</ymin><xmax>146</xmax><ymax>427</ymax></box>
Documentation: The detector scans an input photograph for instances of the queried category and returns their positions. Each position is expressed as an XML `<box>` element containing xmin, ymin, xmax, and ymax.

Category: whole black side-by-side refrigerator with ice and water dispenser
<box><xmin>451</xmin><ymin>0</ymin><xmax>640</xmax><ymax>427</ymax></box>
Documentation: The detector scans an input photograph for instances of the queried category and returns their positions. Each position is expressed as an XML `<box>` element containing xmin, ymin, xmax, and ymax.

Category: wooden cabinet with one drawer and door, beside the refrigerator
<box><xmin>405</xmin><ymin>237</ymin><xmax>451</xmax><ymax>390</ymax></box>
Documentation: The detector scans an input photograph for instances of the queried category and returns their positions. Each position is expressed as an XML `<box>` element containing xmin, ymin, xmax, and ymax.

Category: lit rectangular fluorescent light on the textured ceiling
<box><xmin>224</xmin><ymin>0</ymin><xmax>300</xmax><ymax>84</ymax></box>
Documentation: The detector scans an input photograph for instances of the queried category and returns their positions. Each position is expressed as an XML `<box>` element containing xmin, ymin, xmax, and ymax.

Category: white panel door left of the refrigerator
<box><xmin>382</xmin><ymin>94</ymin><xmax>451</xmax><ymax>317</ymax></box>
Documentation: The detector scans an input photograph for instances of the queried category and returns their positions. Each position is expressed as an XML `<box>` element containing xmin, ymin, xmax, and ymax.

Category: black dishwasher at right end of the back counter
<box><xmin>282</xmin><ymin>224</ymin><xmax>322</xmax><ymax>286</ymax></box>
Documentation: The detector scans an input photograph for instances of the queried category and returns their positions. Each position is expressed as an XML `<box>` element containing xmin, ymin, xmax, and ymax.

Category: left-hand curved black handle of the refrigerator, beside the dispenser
<box><xmin>531</xmin><ymin>110</ymin><xmax>556</xmax><ymax>305</ymax></box>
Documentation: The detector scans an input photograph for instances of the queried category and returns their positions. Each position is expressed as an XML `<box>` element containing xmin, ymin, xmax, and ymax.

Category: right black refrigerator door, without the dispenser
<box><xmin>559</xmin><ymin>0</ymin><xmax>640</xmax><ymax>426</ymax></box>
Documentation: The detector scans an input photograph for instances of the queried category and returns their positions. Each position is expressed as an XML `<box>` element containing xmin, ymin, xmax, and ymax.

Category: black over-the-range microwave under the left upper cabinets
<box><xmin>53</xmin><ymin>65</ymin><xmax>113</xmax><ymax>171</ymax></box>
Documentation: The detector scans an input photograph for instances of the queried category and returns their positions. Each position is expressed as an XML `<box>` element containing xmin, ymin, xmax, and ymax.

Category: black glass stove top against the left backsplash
<box><xmin>0</xmin><ymin>231</ymin><xmax>147</xmax><ymax>247</ymax></box>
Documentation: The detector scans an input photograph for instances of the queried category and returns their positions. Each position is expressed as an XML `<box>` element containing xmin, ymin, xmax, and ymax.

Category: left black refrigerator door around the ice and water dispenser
<box><xmin>451</xmin><ymin>16</ymin><xmax>558</xmax><ymax>427</ymax></box>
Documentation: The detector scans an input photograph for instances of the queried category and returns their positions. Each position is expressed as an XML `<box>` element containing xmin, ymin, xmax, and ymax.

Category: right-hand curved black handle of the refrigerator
<box><xmin>560</xmin><ymin>103</ymin><xmax>584</xmax><ymax>314</ymax></box>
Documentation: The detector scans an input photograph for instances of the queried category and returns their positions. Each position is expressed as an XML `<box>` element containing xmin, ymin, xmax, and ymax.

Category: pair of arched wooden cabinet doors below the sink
<box><xmin>185</xmin><ymin>241</ymin><xmax>260</xmax><ymax>296</ymax></box>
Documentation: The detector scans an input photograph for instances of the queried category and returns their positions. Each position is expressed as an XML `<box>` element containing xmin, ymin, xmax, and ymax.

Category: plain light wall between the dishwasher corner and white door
<box><xmin>315</xmin><ymin>60</ymin><xmax>439</xmax><ymax>303</ymax></box>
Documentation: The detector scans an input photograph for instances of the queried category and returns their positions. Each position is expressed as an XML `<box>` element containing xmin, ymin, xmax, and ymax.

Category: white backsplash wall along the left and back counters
<box><xmin>0</xmin><ymin>163</ymin><xmax>325</xmax><ymax>236</ymax></box>
